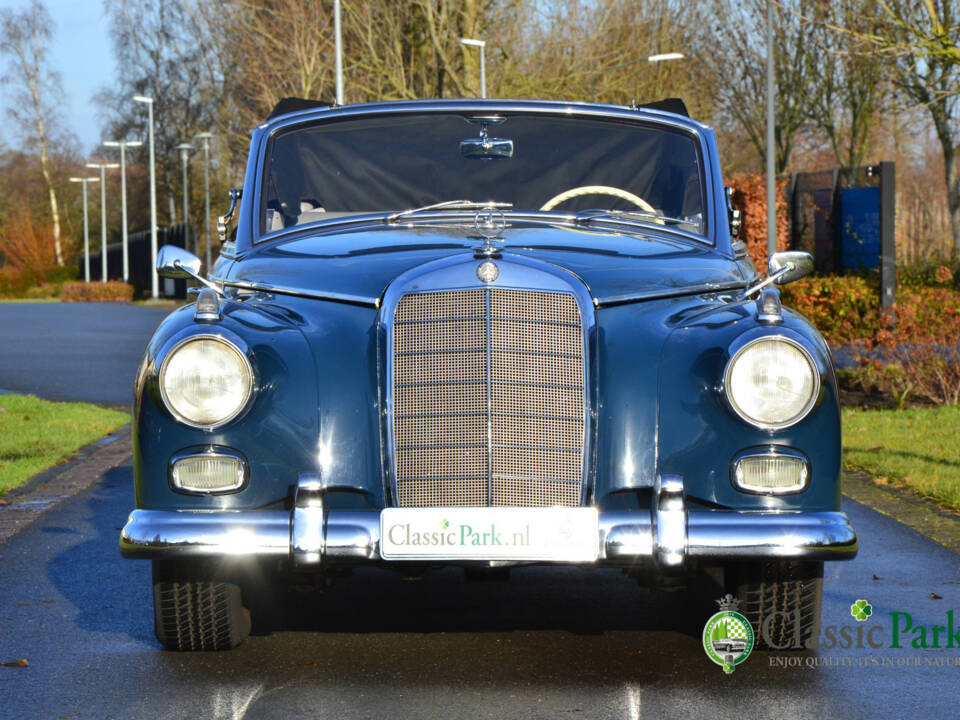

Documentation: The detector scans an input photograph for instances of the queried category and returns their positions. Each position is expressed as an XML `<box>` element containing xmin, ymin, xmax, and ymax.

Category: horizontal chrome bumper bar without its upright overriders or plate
<box><xmin>120</xmin><ymin>510</ymin><xmax>858</xmax><ymax>570</ymax></box>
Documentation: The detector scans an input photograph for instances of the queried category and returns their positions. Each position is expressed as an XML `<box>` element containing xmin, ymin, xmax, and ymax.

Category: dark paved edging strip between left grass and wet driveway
<box><xmin>0</xmin><ymin>423</ymin><xmax>132</xmax><ymax>543</ymax></box>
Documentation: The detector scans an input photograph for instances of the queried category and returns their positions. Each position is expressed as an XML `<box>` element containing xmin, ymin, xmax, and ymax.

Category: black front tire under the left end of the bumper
<box><xmin>153</xmin><ymin>560</ymin><xmax>250</xmax><ymax>651</ymax></box>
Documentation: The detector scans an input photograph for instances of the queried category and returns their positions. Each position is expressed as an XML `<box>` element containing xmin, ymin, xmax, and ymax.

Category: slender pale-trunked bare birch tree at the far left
<box><xmin>0</xmin><ymin>0</ymin><xmax>63</xmax><ymax>266</ymax></box>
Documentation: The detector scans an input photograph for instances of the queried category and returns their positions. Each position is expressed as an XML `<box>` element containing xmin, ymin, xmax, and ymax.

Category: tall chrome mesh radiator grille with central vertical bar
<box><xmin>392</xmin><ymin>288</ymin><xmax>584</xmax><ymax>507</ymax></box>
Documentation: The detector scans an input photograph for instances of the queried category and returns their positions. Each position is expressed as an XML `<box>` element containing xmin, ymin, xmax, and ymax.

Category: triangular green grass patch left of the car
<box><xmin>0</xmin><ymin>395</ymin><xmax>130</xmax><ymax>495</ymax></box>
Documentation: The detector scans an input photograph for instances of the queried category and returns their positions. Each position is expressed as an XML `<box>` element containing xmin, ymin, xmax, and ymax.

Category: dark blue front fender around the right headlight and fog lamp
<box><xmin>657</xmin><ymin>301</ymin><xmax>841</xmax><ymax>511</ymax></box>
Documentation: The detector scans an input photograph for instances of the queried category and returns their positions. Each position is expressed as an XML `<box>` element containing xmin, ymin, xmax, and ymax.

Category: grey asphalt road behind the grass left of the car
<box><xmin>0</xmin><ymin>303</ymin><xmax>170</xmax><ymax>408</ymax></box>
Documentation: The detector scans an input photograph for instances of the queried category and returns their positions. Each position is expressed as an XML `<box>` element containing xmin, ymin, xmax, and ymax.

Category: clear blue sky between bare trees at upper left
<box><xmin>0</xmin><ymin>0</ymin><xmax>116</xmax><ymax>154</ymax></box>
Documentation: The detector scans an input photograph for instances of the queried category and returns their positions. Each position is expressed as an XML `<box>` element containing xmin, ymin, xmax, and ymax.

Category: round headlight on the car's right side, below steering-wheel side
<box><xmin>724</xmin><ymin>338</ymin><xmax>820</xmax><ymax>429</ymax></box>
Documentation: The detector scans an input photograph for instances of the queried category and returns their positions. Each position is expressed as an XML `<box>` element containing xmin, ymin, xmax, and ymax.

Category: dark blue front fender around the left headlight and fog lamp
<box><xmin>133</xmin><ymin>300</ymin><xmax>319</xmax><ymax>510</ymax></box>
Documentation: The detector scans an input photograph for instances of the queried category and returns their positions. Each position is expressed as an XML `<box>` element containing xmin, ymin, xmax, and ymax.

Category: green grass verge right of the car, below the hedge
<box><xmin>842</xmin><ymin>406</ymin><xmax>960</xmax><ymax>511</ymax></box>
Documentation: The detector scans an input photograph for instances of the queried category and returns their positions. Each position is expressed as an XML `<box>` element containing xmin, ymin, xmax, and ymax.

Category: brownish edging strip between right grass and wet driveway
<box><xmin>841</xmin><ymin>470</ymin><xmax>960</xmax><ymax>554</ymax></box>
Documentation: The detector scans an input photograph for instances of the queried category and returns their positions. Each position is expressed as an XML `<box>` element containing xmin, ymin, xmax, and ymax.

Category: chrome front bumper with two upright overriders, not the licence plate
<box><xmin>120</xmin><ymin>475</ymin><xmax>858</xmax><ymax>571</ymax></box>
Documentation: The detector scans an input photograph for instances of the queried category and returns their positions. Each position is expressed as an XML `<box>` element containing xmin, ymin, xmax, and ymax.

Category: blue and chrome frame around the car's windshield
<box><xmin>249</xmin><ymin>100</ymin><xmax>717</xmax><ymax>247</ymax></box>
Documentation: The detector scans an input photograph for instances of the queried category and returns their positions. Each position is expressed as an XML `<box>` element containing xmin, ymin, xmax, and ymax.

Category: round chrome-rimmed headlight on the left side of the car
<box><xmin>160</xmin><ymin>336</ymin><xmax>253</xmax><ymax>428</ymax></box>
